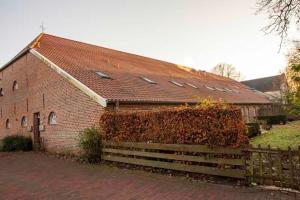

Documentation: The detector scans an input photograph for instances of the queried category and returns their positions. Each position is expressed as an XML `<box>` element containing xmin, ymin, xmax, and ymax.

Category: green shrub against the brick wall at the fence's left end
<box><xmin>79</xmin><ymin>127</ymin><xmax>101</xmax><ymax>163</ymax></box>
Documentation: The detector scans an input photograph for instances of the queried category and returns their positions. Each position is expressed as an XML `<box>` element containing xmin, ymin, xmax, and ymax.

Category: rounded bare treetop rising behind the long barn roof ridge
<box><xmin>211</xmin><ymin>63</ymin><xmax>241</xmax><ymax>80</ymax></box>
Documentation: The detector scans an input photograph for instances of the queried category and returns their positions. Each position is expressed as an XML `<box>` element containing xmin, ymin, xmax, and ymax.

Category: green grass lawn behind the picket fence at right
<box><xmin>250</xmin><ymin>121</ymin><xmax>300</xmax><ymax>149</ymax></box>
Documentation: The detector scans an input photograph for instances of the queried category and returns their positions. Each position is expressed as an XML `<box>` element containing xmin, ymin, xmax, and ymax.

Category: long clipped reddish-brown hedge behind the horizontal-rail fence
<box><xmin>100</xmin><ymin>106</ymin><xmax>248</xmax><ymax>146</ymax></box>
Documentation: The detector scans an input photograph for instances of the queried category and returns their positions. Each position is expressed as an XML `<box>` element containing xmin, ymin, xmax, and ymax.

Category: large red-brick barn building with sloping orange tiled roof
<box><xmin>0</xmin><ymin>34</ymin><xmax>271</xmax><ymax>152</ymax></box>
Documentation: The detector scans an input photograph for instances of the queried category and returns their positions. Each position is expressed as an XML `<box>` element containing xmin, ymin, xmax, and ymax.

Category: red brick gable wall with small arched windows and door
<box><xmin>0</xmin><ymin>53</ymin><xmax>103</xmax><ymax>152</ymax></box>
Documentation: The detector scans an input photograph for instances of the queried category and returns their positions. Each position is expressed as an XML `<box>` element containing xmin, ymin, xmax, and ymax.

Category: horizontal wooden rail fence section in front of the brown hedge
<box><xmin>102</xmin><ymin>141</ymin><xmax>246</xmax><ymax>179</ymax></box>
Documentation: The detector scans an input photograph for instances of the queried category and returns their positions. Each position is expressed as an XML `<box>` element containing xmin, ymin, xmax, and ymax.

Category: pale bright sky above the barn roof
<box><xmin>0</xmin><ymin>0</ymin><xmax>298</xmax><ymax>80</ymax></box>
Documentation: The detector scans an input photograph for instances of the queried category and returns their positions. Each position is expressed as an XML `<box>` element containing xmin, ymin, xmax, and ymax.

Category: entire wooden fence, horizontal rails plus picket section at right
<box><xmin>102</xmin><ymin>141</ymin><xmax>300</xmax><ymax>190</ymax></box>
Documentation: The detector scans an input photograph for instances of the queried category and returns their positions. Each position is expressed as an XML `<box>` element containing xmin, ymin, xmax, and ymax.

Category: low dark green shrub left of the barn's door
<box><xmin>2</xmin><ymin>135</ymin><xmax>32</xmax><ymax>151</ymax></box>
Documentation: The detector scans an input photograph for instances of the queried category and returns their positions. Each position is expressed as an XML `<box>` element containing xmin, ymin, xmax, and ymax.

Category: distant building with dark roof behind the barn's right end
<box><xmin>241</xmin><ymin>74</ymin><xmax>287</xmax><ymax>103</ymax></box>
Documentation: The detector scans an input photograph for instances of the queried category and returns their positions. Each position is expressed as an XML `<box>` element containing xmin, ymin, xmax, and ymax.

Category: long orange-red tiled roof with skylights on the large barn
<box><xmin>1</xmin><ymin>34</ymin><xmax>270</xmax><ymax>104</ymax></box>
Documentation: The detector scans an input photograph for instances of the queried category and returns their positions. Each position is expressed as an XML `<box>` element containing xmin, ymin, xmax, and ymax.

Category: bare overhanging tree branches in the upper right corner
<box><xmin>257</xmin><ymin>0</ymin><xmax>300</xmax><ymax>48</ymax></box>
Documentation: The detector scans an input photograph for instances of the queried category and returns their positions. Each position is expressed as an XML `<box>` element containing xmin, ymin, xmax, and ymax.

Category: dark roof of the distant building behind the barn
<box><xmin>241</xmin><ymin>74</ymin><xmax>284</xmax><ymax>92</ymax></box>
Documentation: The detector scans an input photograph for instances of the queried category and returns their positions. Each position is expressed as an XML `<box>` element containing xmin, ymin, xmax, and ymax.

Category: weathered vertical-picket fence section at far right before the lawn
<box><xmin>246</xmin><ymin>145</ymin><xmax>300</xmax><ymax>190</ymax></box>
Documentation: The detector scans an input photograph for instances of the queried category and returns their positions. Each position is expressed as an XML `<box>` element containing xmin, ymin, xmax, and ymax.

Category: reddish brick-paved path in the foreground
<box><xmin>0</xmin><ymin>153</ymin><xmax>300</xmax><ymax>200</ymax></box>
